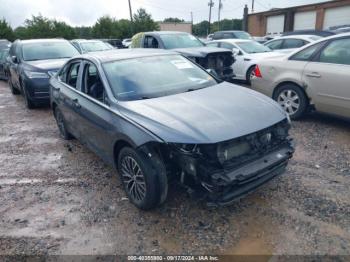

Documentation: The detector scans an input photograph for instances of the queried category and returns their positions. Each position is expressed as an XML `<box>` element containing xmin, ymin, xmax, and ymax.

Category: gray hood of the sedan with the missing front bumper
<box><xmin>120</xmin><ymin>82</ymin><xmax>286</xmax><ymax>144</ymax></box>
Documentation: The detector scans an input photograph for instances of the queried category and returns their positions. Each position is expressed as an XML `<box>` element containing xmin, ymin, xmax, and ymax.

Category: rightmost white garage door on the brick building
<box><xmin>323</xmin><ymin>6</ymin><xmax>350</xmax><ymax>29</ymax></box>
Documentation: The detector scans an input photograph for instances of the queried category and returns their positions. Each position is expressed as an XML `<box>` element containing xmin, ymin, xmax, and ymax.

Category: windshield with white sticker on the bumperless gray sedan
<box><xmin>103</xmin><ymin>55</ymin><xmax>217</xmax><ymax>101</ymax></box>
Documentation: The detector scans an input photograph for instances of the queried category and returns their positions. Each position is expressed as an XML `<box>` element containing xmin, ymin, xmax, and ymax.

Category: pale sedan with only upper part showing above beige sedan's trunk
<box><xmin>264</xmin><ymin>35</ymin><xmax>322</xmax><ymax>53</ymax></box>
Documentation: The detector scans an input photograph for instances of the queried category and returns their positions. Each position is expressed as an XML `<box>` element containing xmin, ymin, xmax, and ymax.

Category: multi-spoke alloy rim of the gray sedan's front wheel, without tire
<box><xmin>121</xmin><ymin>156</ymin><xmax>146</xmax><ymax>202</ymax></box>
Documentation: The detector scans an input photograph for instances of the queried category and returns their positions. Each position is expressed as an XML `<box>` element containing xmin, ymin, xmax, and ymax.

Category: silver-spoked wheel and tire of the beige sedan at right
<box><xmin>273</xmin><ymin>84</ymin><xmax>309</xmax><ymax>119</ymax></box>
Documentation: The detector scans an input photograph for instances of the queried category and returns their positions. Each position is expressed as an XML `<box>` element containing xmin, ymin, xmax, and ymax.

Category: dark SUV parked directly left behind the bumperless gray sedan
<box><xmin>8</xmin><ymin>39</ymin><xmax>79</xmax><ymax>109</ymax></box>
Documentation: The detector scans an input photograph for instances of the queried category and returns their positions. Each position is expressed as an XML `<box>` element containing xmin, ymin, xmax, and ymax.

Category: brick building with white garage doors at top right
<box><xmin>247</xmin><ymin>0</ymin><xmax>350</xmax><ymax>36</ymax></box>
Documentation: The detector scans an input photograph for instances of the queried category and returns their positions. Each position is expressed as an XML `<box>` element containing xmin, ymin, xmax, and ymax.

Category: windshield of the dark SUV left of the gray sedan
<box><xmin>22</xmin><ymin>41</ymin><xmax>79</xmax><ymax>61</ymax></box>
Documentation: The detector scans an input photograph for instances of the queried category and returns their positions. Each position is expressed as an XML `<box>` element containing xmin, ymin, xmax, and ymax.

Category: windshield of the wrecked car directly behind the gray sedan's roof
<box><xmin>159</xmin><ymin>34</ymin><xmax>204</xmax><ymax>49</ymax></box>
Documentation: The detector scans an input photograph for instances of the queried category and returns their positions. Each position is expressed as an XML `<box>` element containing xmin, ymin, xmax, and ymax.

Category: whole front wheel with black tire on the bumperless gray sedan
<box><xmin>117</xmin><ymin>147</ymin><xmax>168</xmax><ymax>210</ymax></box>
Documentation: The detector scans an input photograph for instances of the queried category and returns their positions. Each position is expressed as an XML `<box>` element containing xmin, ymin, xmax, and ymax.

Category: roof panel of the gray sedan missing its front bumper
<box><xmin>79</xmin><ymin>48</ymin><xmax>179</xmax><ymax>63</ymax></box>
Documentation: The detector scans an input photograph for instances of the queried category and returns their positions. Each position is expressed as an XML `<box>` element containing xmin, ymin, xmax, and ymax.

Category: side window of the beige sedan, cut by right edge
<box><xmin>319</xmin><ymin>38</ymin><xmax>350</xmax><ymax>65</ymax></box>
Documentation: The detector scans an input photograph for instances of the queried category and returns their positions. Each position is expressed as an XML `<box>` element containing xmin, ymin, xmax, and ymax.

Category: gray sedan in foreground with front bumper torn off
<box><xmin>50</xmin><ymin>49</ymin><xmax>294</xmax><ymax>209</ymax></box>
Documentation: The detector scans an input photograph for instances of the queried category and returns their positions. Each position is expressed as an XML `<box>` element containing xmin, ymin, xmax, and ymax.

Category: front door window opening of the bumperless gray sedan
<box><xmin>82</xmin><ymin>63</ymin><xmax>105</xmax><ymax>103</ymax></box>
